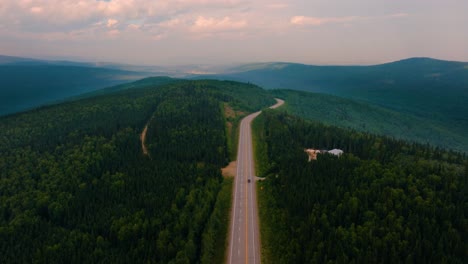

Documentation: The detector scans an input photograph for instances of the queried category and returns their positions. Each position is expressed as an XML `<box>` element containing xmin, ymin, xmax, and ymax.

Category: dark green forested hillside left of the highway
<box><xmin>0</xmin><ymin>78</ymin><xmax>274</xmax><ymax>263</ymax></box>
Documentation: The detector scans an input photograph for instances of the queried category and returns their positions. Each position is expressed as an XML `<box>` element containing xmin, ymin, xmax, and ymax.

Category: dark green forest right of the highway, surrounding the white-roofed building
<box><xmin>254</xmin><ymin>111</ymin><xmax>468</xmax><ymax>263</ymax></box>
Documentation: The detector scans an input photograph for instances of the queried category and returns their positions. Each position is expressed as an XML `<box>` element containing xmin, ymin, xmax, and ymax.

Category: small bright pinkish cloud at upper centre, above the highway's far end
<box><xmin>191</xmin><ymin>16</ymin><xmax>247</xmax><ymax>32</ymax></box>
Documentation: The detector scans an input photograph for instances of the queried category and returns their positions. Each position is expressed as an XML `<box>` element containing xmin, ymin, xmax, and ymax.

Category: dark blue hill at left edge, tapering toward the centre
<box><xmin>0</xmin><ymin>62</ymin><xmax>149</xmax><ymax>115</ymax></box>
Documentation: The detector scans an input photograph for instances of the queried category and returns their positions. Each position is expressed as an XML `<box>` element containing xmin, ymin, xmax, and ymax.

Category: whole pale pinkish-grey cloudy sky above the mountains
<box><xmin>0</xmin><ymin>0</ymin><xmax>468</xmax><ymax>65</ymax></box>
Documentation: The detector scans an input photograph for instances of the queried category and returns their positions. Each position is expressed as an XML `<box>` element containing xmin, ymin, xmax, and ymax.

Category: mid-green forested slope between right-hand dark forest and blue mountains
<box><xmin>270</xmin><ymin>90</ymin><xmax>468</xmax><ymax>153</ymax></box>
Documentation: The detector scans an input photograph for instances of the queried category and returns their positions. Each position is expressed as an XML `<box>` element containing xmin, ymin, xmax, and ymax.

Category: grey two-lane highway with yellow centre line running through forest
<box><xmin>228</xmin><ymin>99</ymin><xmax>284</xmax><ymax>264</ymax></box>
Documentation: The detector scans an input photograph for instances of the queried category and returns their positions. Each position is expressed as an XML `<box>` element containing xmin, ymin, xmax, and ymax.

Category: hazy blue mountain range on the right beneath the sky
<box><xmin>207</xmin><ymin>58</ymin><xmax>468</xmax><ymax>140</ymax></box>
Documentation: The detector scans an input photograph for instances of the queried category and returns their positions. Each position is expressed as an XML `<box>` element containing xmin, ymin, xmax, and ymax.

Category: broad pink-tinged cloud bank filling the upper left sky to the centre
<box><xmin>0</xmin><ymin>0</ymin><xmax>251</xmax><ymax>44</ymax></box>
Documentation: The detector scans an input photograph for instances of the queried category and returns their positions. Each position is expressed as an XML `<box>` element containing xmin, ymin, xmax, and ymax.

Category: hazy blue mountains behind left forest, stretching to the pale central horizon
<box><xmin>0</xmin><ymin>55</ymin><xmax>232</xmax><ymax>116</ymax></box>
